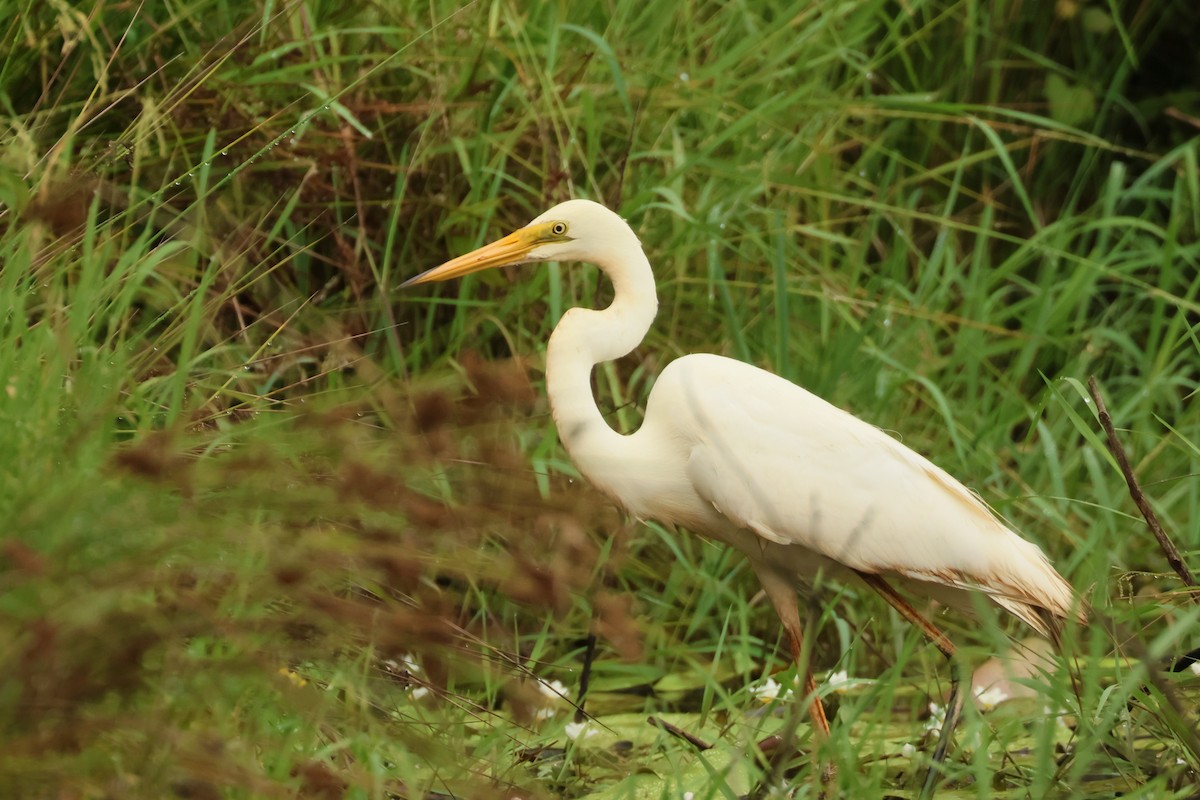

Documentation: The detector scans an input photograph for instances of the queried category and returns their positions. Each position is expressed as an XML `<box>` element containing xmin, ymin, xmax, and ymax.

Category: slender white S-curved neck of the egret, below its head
<box><xmin>546</xmin><ymin>235</ymin><xmax>659</xmax><ymax>470</ymax></box>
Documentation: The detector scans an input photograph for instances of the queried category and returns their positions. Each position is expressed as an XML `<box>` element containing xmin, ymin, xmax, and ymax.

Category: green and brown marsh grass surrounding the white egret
<box><xmin>0</xmin><ymin>0</ymin><xmax>1200</xmax><ymax>798</ymax></box>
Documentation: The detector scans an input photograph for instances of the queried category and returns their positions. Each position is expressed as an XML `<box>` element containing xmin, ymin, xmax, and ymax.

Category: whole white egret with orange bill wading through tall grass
<box><xmin>403</xmin><ymin>200</ymin><xmax>1084</xmax><ymax>778</ymax></box>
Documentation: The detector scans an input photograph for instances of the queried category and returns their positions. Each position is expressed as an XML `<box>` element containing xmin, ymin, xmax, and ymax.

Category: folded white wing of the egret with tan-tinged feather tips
<box><xmin>662</xmin><ymin>356</ymin><xmax>1070</xmax><ymax>613</ymax></box>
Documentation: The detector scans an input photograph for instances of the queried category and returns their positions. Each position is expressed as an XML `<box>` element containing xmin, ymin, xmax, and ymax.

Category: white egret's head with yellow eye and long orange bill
<box><xmin>401</xmin><ymin>200</ymin><xmax>637</xmax><ymax>288</ymax></box>
